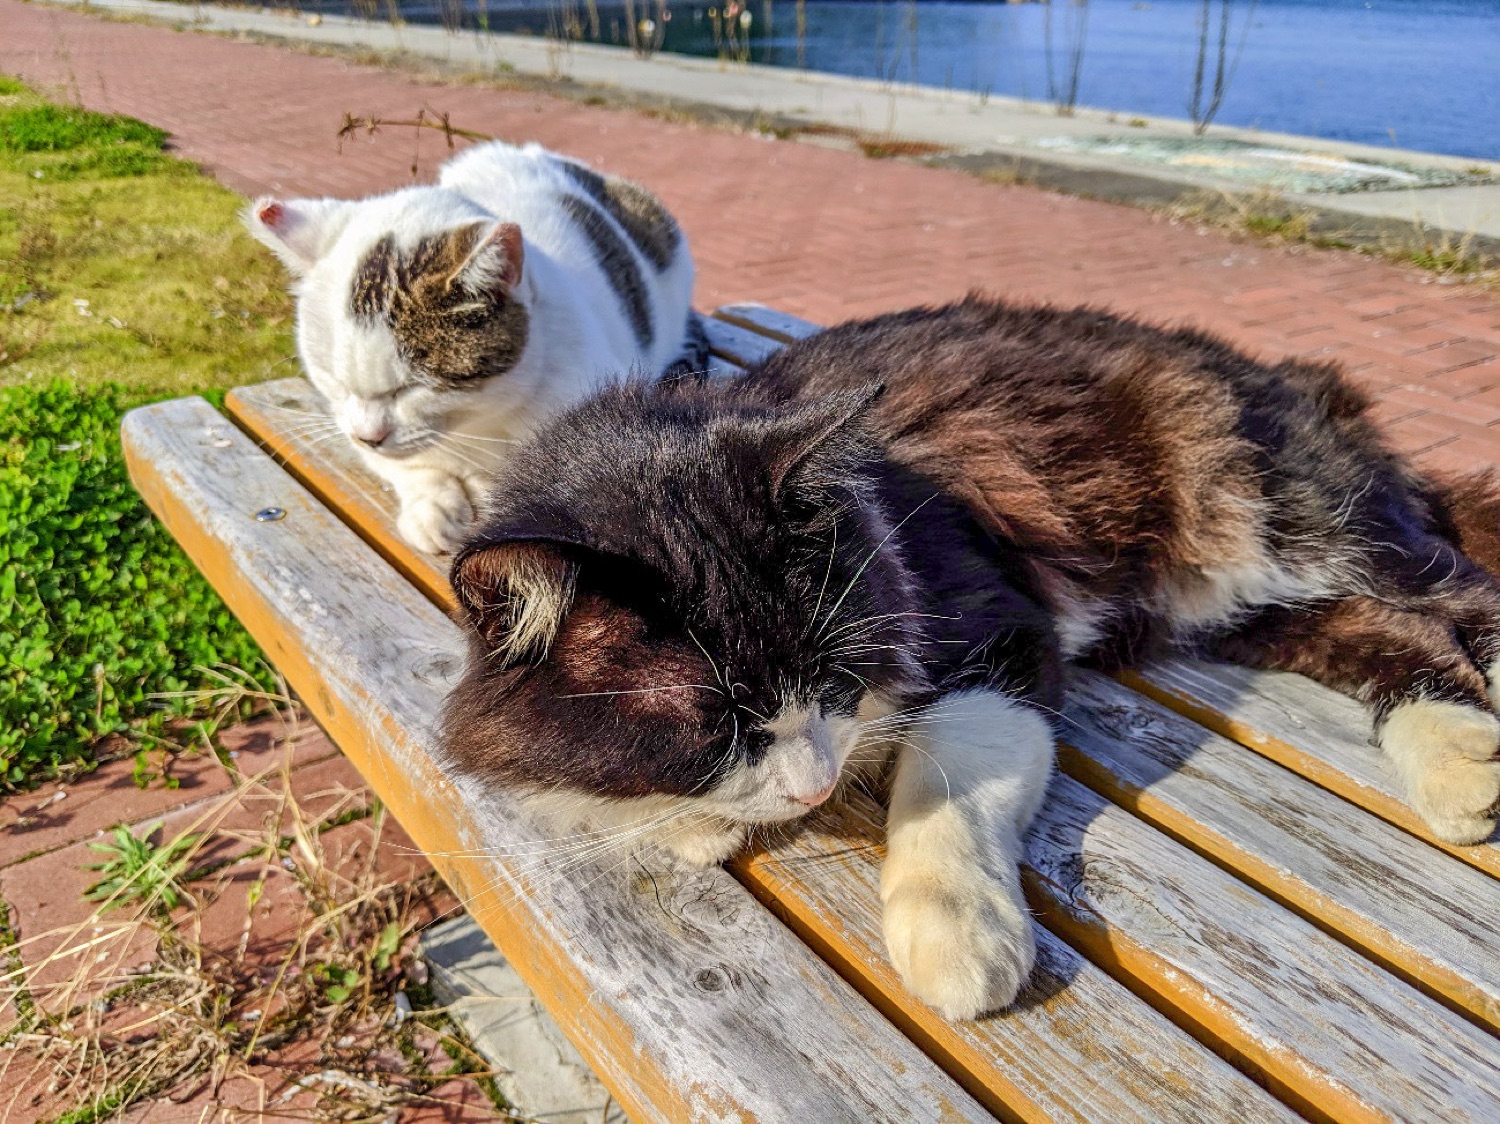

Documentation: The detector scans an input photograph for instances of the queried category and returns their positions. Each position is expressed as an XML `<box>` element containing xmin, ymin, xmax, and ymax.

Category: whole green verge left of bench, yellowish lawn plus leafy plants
<box><xmin>0</xmin><ymin>75</ymin><xmax>293</xmax><ymax>791</ymax></box>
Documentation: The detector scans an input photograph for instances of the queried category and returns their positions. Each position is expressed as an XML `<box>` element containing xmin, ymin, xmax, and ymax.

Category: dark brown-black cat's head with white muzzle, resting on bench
<box><xmin>446</xmin><ymin>376</ymin><xmax>923</xmax><ymax>822</ymax></box>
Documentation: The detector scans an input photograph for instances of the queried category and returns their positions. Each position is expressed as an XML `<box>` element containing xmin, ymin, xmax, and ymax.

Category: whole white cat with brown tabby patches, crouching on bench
<box><xmin>246</xmin><ymin>141</ymin><xmax>704</xmax><ymax>552</ymax></box>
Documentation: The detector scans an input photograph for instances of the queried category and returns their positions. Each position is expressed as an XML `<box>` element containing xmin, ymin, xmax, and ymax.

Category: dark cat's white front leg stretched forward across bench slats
<box><xmin>881</xmin><ymin>689</ymin><xmax>1053</xmax><ymax>1019</ymax></box>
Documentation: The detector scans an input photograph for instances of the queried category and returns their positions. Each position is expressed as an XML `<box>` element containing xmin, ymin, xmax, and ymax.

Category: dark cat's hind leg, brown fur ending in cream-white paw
<box><xmin>1211</xmin><ymin>597</ymin><xmax>1500</xmax><ymax>843</ymax></box>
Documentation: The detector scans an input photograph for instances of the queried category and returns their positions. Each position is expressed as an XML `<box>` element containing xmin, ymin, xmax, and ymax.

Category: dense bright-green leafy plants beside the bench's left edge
<box><xmin>0</xmin><ymin>381</ymin><xmax>272</xmax><ymax>789</ymax></box>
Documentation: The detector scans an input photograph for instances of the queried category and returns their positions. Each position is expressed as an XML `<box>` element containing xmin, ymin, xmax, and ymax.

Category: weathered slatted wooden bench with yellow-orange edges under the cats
<box><xmin>125</xmin><ymin>306</ymin><xmax>1500</xmax><ymax>1124</ymax></box>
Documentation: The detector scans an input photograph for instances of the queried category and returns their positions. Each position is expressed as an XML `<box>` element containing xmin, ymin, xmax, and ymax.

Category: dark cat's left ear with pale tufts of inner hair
<box><xmin>450</xmin><ymin>539</ymin><xmax>578</xmax><ymax>671</ymax></box>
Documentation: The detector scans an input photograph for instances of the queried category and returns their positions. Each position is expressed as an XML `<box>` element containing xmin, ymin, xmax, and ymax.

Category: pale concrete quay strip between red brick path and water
<box><xmin>35</xmin><ymin>0</ymin><xmax>1500</xmax><ymax>252</ymax></box>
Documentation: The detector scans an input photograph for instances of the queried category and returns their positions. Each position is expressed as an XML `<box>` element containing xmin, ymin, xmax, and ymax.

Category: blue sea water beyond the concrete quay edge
<box><xmin>303</xmin><ymin>0</ymin><xmax>1500</xmax><ymax>159</ymax></box>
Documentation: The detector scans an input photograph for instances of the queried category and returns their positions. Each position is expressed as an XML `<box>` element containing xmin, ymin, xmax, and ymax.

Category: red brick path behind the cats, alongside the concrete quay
<box><xmin>0</xmin><ymin>0</ymin><xmax>1500</xmax><ymax>468</ymax></box>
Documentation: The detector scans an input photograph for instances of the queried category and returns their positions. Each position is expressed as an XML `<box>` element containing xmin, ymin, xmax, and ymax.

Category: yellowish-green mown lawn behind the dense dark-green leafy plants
<box><xmin>0</xmin><ymin>85</ymin><xmax>293</xmax><ymax>396</ymax></box>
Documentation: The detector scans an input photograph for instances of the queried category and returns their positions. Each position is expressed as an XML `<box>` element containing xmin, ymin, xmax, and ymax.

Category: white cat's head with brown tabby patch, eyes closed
<box><xmin>246</xmin><ymin>188</ymin><xmax>530</xmax><ymax>456</ymax></box>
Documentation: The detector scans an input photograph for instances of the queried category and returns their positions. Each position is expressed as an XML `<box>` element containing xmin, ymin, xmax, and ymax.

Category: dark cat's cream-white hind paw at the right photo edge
<box><xmin>1380</xmin><ymin>699</ymin><xmax>1500</xmax><ymax>843</ymax></box>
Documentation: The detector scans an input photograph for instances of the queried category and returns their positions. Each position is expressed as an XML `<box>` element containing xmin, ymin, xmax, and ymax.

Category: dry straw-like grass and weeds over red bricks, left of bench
<box><xmin>0</xmin><ymin>705</ymin><xmax>504</xmax><ymax>1124</ymax></box>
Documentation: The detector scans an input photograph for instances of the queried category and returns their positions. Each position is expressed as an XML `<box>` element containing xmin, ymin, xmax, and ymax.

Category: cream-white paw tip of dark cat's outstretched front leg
<box><xmin>882</xmin><ymin>867</ymin><xmax>1037</xmax><ymax>1019</ymax></box>
